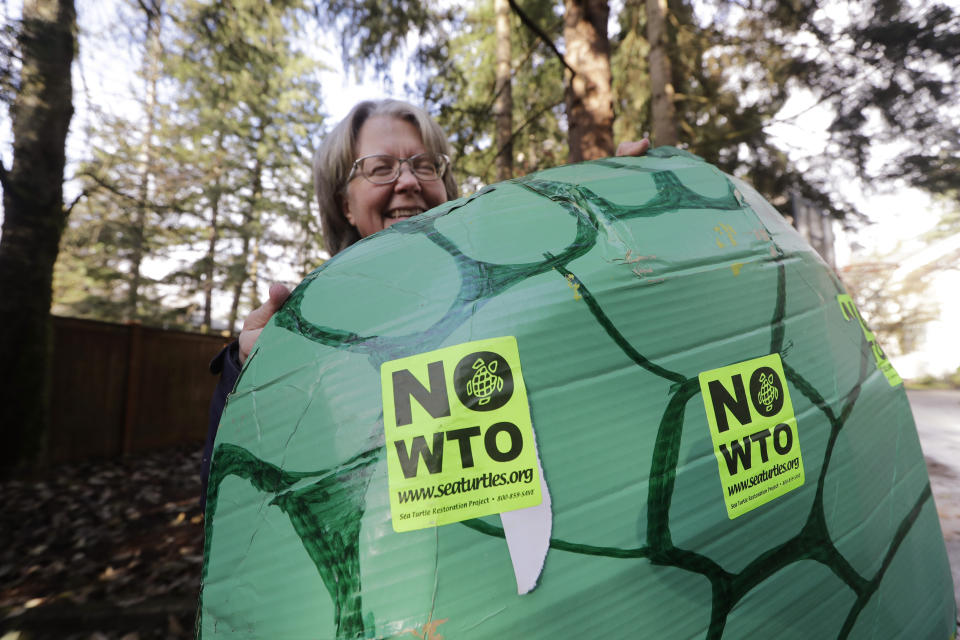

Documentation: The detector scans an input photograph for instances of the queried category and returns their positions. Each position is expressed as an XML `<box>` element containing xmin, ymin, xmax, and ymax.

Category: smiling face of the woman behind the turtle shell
<box><xmin>343</xmin><ymin>116</ymin><xmax>447</xmax><ymax>238</ymax></box>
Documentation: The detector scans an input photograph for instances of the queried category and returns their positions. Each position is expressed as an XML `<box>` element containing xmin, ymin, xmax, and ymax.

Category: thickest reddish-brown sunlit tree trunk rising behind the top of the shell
<box><xmin>563</xmin><ymin>0</ymin><xmax>614</xmax><ymax>162</ymax></box>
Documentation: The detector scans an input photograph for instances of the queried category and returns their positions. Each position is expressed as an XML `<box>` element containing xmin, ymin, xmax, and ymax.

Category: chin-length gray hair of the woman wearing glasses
<box><xmin>313</xmin><ymin>99</ymin><xmax>459</xmax><ymax>256</ymax></box>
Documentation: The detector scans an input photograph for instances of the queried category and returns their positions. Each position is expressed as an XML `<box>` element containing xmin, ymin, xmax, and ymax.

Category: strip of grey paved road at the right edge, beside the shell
<box><xmin>907</xmin><ymin>391</ymin><xmax>960</xmax><ymax>607</ymax></box>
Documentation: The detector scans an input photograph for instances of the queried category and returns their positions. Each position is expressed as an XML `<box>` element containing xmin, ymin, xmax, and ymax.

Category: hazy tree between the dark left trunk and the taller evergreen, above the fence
<box><xmin>53</xmin><ymin>0</ymin><xmax>176</xmax><ymax>324</ymax></box>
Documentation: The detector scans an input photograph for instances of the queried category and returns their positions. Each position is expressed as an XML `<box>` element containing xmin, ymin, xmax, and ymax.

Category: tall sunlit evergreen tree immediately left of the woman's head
<box><xmin>168</xmin><ymin>0</ymin><xmax>322</xmax><ymax>327</ymax></box>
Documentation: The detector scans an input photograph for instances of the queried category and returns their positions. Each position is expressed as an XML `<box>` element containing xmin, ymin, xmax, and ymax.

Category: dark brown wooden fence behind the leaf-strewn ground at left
<box><xmin>49</xmin><ymin>317</ymin><xmax>230</xmax><ymax>464</ymax></box>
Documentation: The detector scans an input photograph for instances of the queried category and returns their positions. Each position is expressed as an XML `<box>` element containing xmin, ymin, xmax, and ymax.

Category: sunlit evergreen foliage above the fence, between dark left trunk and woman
<box><xmin>56</xmin><ymin>0</ymin><xmax>322</xmax><ymax>329</ymax></box>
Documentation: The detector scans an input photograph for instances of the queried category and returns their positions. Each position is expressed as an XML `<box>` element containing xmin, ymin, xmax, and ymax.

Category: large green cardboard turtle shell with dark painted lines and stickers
<box><xmin>198</xmin><ymin>148</ymin><xmax>955</xmax><ymax>640</ymax></box>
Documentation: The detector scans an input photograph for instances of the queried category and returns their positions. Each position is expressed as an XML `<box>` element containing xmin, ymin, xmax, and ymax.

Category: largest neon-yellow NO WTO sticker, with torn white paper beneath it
<box><xmin>380</xmin><ymin>336</ymin><xmax>542</xmax><ymax>531</ymax></box>
